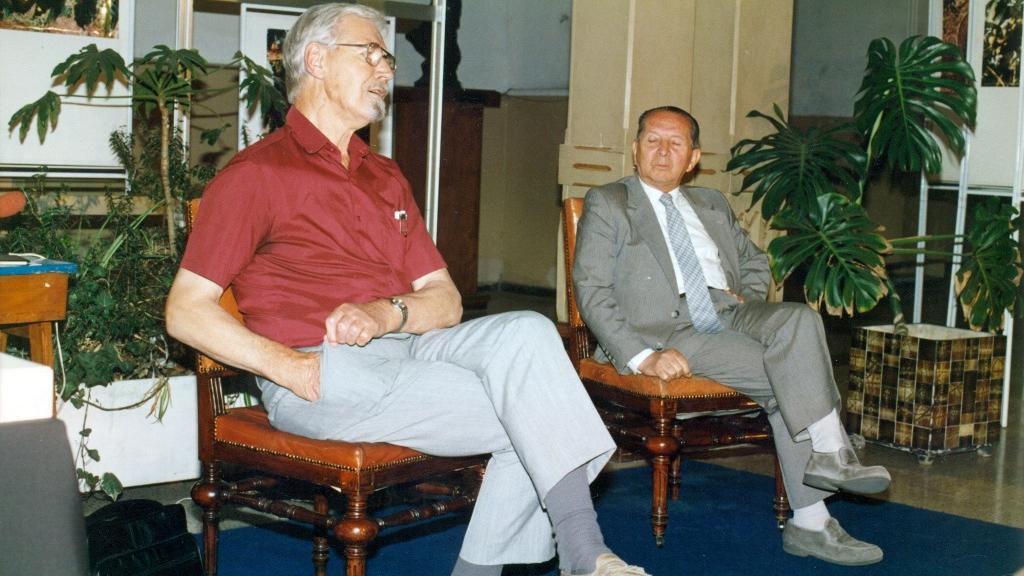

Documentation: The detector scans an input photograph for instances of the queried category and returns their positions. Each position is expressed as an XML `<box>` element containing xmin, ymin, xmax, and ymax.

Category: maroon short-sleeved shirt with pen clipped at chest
<box><xmin>181</xmin><ymin>108</ymin><xmax>445</xmax><ymax>347</ymax></box>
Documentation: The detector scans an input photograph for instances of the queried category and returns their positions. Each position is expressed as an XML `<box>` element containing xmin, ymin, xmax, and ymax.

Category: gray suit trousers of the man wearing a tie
<box><xmin>669</xmin><ymin>301</ymin><xmax>840</xmax><ymax>508</ymax></box>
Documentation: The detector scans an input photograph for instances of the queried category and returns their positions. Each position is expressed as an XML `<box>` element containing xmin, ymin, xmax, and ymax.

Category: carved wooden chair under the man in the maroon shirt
<box><xmin>187</xmin><ymin>200</ymin><xmax>487</xmax><ymax>576</ymax></box>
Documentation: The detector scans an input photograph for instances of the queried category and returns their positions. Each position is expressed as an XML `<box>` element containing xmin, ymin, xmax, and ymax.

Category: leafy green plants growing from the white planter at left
<box><xmin>0</xmin><ymin>45</ymin><xmax>285</xmax><ymax>498</ymax></box>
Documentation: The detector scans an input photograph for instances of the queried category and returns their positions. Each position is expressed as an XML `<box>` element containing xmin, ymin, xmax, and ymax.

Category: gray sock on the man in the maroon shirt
<box><xmin>545</xmin><ymin>466</ymin><xmax>610</xmax><ymax>574</ymax></box>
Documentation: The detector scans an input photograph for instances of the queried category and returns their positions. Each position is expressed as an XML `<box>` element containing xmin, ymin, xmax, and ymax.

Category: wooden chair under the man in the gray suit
<box><xmin>562</xmin><ymin>198</ymin><xmax>790</xmax><ymax>546</ymax></box>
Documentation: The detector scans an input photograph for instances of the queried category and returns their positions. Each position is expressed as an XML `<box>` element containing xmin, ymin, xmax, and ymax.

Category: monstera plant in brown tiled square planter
<box><xmin>727</xmin><ymin>37</ymin><xmax>1021</xmax><ymax>455</ymax></box>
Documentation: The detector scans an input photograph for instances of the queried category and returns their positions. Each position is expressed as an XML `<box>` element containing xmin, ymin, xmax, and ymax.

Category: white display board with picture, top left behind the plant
<box><xmin>0</xmin><ymin>0</ymin><xmax>134</xmax><ymax>177</ymax></box>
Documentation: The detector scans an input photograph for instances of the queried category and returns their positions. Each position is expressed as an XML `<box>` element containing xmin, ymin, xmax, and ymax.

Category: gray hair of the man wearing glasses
<box><xmin>282</xmin><ymin>3</ymin><xmax>387</xmax><ymax>102</ymax></box>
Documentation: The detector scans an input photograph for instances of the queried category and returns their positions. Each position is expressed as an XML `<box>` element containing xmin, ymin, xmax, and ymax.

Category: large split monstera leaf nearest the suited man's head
<box><xmin>726</xmin><ymin>105</ymin><xmax>865</xmax><ymax>219</ymax></box>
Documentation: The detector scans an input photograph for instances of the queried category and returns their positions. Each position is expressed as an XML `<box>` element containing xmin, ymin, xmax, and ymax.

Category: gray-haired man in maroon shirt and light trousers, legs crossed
<box><xmin>167</xmin><ymin>4</ymin><xmax>645</xmax><ymax>576</ymax></box>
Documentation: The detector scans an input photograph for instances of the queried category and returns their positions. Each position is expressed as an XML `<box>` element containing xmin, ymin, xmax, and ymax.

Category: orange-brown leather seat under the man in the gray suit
<box><xmin>580</xmin><ymin>358</ymin><xmax>741</xmax><ymax>399</ymax></box>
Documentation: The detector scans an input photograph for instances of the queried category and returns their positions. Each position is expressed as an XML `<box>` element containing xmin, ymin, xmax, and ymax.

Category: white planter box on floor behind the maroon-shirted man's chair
<box><xmin>57</xmin><ymin>376</ymin><xmax>200</xmax><ymax>488</ymax></box>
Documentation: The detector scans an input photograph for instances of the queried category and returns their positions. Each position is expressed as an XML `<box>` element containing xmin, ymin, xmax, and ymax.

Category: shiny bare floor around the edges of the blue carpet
<box><xmin>87</xmin><ymin>292</ymin><xmax>1024</xmax><ymax>531</ymax></box>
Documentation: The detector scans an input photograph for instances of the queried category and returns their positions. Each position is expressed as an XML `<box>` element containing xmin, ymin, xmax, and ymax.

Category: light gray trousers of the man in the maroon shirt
<box><xmin>261</xmin><ymin>313</ymin><xmax>615</xmax><ymax>565</ymax></box>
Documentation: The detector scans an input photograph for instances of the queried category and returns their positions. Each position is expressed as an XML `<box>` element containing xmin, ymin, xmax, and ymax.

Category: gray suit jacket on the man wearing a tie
<box><xmin>572</xmin><ymin>176</ymin><xmax>771</xmax><ymax>374</ymax></box>
